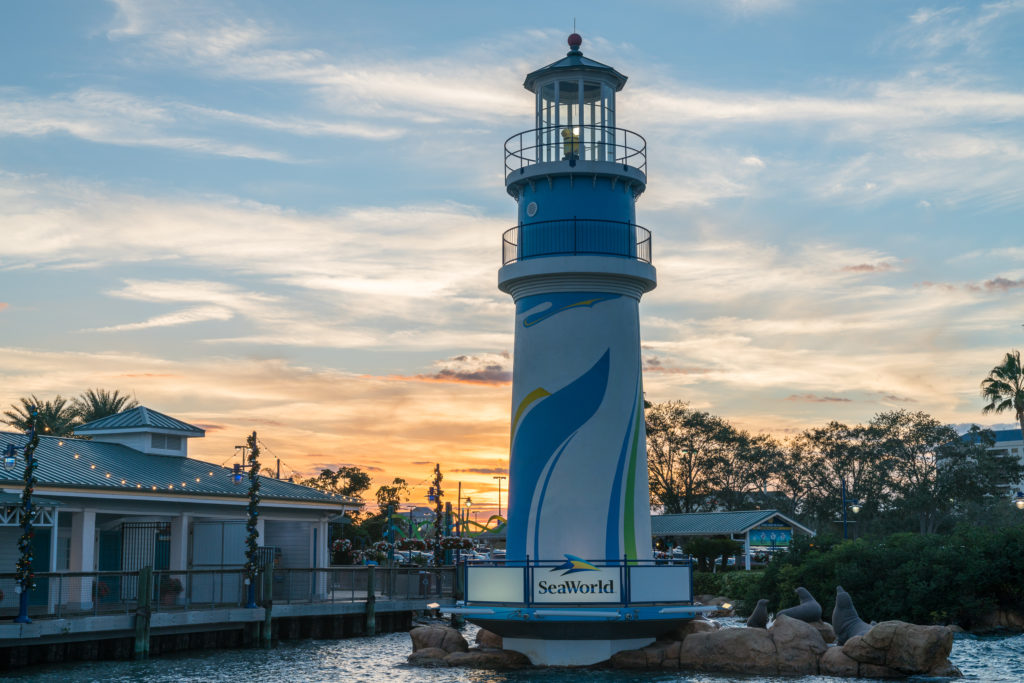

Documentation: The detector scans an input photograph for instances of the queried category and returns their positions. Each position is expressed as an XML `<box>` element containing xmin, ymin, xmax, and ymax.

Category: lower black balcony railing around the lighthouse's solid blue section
<box><xmin>502</xmin><ymin>218</ymin><xmax>651</xmax><ymax>265</ymax></box>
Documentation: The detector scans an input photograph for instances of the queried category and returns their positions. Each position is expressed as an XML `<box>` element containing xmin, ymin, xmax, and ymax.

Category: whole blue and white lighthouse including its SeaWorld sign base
<box><xmin>445</xmin><ymin>33</ymin><xmax>706</xmax><ymax>666</ymax></box>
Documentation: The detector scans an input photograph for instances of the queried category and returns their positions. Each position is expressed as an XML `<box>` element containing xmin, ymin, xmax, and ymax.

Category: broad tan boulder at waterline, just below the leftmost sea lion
<box><xmin>679</xmin><ymin>629</ymin><xmax>777</xmax><ymax>675</ymax></box>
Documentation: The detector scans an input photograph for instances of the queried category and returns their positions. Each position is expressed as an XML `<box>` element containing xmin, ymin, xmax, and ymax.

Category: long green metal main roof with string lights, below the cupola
<box><xmin>0</xmin><ymin>432</ymin><xmax>360</xmax><ymax>505</ymax></box>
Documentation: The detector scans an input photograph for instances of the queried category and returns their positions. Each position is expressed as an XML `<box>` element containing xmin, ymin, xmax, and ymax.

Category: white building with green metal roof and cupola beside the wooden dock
<box><xmin>0</xmin><ymin>405</ymin><xmax>362</xmax><ymax>610</ymax></box>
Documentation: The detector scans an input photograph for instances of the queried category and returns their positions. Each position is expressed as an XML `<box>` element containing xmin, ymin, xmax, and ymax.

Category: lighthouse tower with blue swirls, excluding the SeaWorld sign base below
<box><xmin>498</xmin><ymin>34</ymin><xmax>656</xmax><ymax>573</ymax></box>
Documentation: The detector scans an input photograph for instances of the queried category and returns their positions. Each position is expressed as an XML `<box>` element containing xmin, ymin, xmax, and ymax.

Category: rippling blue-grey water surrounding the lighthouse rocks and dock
<box><xmin>3</xmin><ymin>627</ymin><xmax>1024</xmax><ymax>683</ymax></box>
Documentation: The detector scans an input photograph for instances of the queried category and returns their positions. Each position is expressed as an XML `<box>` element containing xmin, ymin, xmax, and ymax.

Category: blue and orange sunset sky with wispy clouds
<box><xmin>0</xmin><ymin>0</ymin><xmax>1024</xmax><ymax>512</ymax></box>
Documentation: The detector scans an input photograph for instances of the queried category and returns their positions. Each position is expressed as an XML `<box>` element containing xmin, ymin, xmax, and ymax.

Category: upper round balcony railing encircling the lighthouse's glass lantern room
<box><xmin>505</xmin><ymin>125</ymin><xmax>647</xmax><ymax>175</ymax></box>
